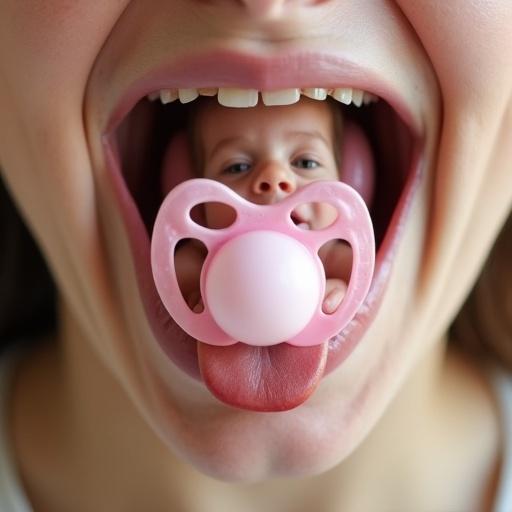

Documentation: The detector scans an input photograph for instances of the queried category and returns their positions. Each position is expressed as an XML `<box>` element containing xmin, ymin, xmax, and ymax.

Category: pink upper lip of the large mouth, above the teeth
<box><xmin>103</xmin><ymin>50</ymin><xmax>425</xmax><ymax>138</ymax></box>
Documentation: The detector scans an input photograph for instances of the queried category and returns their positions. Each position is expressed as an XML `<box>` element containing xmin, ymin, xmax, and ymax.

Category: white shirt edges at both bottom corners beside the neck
<box><xmin>0</xmin><ymin>350</ymin><xmax>512</xmax><ymax>512</ymax></box>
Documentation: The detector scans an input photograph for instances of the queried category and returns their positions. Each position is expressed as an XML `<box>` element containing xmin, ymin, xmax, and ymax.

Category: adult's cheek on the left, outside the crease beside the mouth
<box><xmin>0</xmin><ymin>0</ymin><xmax>132</xmax><ymax>358</ymax></box>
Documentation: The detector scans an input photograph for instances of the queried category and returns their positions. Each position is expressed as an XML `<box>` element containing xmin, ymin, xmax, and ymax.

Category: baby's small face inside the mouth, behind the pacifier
<box><xmin>196</xmin><ymin>98</ymin><xmax>340</xmax><ymax>229</ymax></box>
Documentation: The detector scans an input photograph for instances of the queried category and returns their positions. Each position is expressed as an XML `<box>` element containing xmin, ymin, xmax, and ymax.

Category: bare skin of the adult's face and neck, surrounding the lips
<box><xmin>0</xmin><ymin>0</ymin><xmax>512</xmax><ymax>511</ymax></box>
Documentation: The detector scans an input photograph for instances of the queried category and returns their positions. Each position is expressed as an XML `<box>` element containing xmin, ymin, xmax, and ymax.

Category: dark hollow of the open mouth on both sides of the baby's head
<box><xmin>113</xmin><ymin>91</ymin><xmax>417</xmax><ymax>257</ymax></box>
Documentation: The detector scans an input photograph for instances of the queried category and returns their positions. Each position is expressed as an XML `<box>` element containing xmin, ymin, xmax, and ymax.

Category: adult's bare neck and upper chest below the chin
<box><xmin>13</xmin><ymin>308</ymin><xmax>499</xmax><ymax>512</ymax></box>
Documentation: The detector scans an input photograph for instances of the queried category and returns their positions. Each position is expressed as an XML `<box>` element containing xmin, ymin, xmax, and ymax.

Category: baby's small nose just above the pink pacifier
<box><xmin>252</xmin><ymin>162</ymin><xmax>297</xmax><ymax>202</ymax></box>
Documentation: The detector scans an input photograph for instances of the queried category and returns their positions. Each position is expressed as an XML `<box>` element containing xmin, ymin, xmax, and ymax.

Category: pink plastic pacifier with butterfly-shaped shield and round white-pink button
<box><xmin>151</xmin><ymin>179</ymin><xmax>375</xmax><ymax>346</ymax></box>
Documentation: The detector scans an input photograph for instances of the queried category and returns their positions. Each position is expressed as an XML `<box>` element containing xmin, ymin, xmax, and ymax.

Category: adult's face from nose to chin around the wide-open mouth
<box><xmin>0</xmin><ymin>0</ymin><xmax>512</xmax><ymax>480</ymax></box>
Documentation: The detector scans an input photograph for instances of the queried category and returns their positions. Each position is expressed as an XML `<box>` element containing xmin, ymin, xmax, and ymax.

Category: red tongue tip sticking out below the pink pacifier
<box><xmin>197</xmin><ymin>342</ymin><xmax>328</xmax><ymax>412</ymax></box>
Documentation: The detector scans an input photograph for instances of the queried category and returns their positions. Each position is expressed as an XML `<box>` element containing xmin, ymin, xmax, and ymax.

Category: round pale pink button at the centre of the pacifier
<box><xmin>204</xmin><ymin>231</ymin><xmax>325</xmax><ymax>346</ymax></box>
